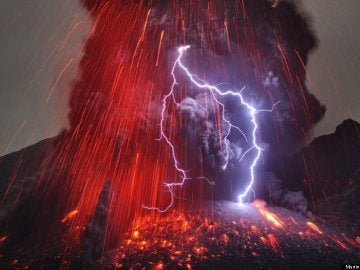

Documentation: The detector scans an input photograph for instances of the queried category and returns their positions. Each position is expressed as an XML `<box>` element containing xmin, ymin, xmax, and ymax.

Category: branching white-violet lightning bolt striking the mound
<box><xmin>143</xmin><ymin>45</ymin><xmax>280</xmax><ymax>213</ymax></box>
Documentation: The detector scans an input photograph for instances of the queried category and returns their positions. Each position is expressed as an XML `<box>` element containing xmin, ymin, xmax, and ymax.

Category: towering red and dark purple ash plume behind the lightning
<box><xmin>30</xmin><ymin>0</ymin><xmax>325</xmax><ymax>249</ymax></box>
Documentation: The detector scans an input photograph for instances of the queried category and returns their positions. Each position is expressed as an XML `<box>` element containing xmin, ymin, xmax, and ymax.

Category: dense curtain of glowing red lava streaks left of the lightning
<box><xmin>37</xmin><ymin>2</ymin><xmax>179</xmax><ymax>248</ymax></box>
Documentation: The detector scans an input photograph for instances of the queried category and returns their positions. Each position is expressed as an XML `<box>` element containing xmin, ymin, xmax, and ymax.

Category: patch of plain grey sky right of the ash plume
<box><xmin>300</xmin><ymin>0</ymin><xmax>360</xmax><ymax>138</ymax></box>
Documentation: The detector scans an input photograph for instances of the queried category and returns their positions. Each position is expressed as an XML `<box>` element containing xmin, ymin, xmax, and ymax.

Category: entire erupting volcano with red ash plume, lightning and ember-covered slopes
<box><xmin>0</xmin><ymin>0</ymin><xmax>360</xmax><ymax>269</ymax></box>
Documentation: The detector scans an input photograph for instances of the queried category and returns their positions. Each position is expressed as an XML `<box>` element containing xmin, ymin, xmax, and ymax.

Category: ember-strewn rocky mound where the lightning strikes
<box><xmin>112</xmin><ymin>201</ymin><xmax>360</xmax><ymax>269</ymax></box>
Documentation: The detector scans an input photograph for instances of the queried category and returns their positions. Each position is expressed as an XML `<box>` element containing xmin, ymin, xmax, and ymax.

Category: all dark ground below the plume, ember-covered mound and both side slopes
<box><xmin>0</xmin><ymin>120</ymin><xmax>360</xmax><ymax>269</ymax></box>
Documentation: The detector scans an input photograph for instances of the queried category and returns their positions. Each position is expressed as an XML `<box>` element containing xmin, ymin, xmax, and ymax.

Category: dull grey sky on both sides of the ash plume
<box><xmin>0</xmin><ymin>0</ymin><xmax>360</xmax><ymax>156</ymax></box>
